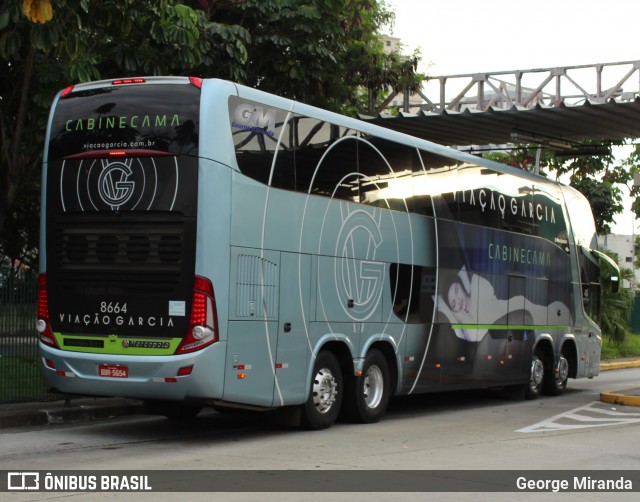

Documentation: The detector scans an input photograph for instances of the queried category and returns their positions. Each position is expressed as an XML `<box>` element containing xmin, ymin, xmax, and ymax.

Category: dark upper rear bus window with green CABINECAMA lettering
<box><xmin>49</xmin><ymin>84</ymin><xmax>200</xmax><ymax>160</ymax></box>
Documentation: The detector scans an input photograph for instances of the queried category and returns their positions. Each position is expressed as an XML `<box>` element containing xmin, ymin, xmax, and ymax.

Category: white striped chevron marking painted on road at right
<box><xmin>516</xmin><ymin>401</ymin><xmax>640</xmax><ymax>433</ymax></box>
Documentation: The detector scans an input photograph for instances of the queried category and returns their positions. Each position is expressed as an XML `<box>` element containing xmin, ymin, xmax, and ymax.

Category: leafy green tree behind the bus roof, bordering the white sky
<box><xmin>198</xmin><ymin>0</ymin><xmax>424</xmax><ymax>114</ymax></box>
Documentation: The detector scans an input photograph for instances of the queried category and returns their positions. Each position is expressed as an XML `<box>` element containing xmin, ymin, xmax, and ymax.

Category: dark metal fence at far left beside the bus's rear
<box><xmin>0</xmin><ymin>266</ymin><xmax>55</xmax><ymax>404</ymax></box>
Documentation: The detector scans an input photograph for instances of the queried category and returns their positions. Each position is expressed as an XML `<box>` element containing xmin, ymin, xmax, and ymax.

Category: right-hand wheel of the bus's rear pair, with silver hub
<box><xmin>342</xmin><ymin>349</ymin><xmax>391</xmax><ymax>424</ymax></box>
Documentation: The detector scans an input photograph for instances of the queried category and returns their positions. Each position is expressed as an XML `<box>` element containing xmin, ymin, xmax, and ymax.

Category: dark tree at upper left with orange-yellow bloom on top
<box><xmin>0</xmin><ymin>0</ymin><xmax>249</xmax><ymax>247</ymax></box>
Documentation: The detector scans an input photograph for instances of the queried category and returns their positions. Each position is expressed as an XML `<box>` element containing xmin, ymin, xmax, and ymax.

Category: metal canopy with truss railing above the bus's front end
<box><xmin>361</xmin><ymin>60</ymin><xmax>640</xmax><ymax>150</ymax></box>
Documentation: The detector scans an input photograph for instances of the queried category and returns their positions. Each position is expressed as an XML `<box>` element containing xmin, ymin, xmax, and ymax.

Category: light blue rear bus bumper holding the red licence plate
<box><xmin>39</xmin><ymin>342</ymin><xmax>226</xmax><ymax>401</ymax></box>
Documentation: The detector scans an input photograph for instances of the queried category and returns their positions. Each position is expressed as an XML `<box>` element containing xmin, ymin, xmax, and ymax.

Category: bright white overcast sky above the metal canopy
<box><xmin>386</xmin><ymin>0</ymin><xmax>640</xmax><ymax>234</ymax></box>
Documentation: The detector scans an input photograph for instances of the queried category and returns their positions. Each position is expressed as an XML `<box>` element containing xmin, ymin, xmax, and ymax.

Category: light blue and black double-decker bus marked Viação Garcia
<box><xmin>37</xmin><ymin>77</ymin><xmax>616</xmax><ymax>429</ymax></box>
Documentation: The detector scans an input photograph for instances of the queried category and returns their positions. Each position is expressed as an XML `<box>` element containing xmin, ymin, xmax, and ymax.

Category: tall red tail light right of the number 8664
<box><xmin>176</xmin><ymin>276</ymin><xmax>218</xmax><ymax>354</ymax></box>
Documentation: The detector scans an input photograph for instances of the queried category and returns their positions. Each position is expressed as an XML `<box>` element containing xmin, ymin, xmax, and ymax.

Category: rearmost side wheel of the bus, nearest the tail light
<box><xmin>301</xmin><ymin>351</ymin><xmax>344</xmax><ymax>430</ymax></box>
